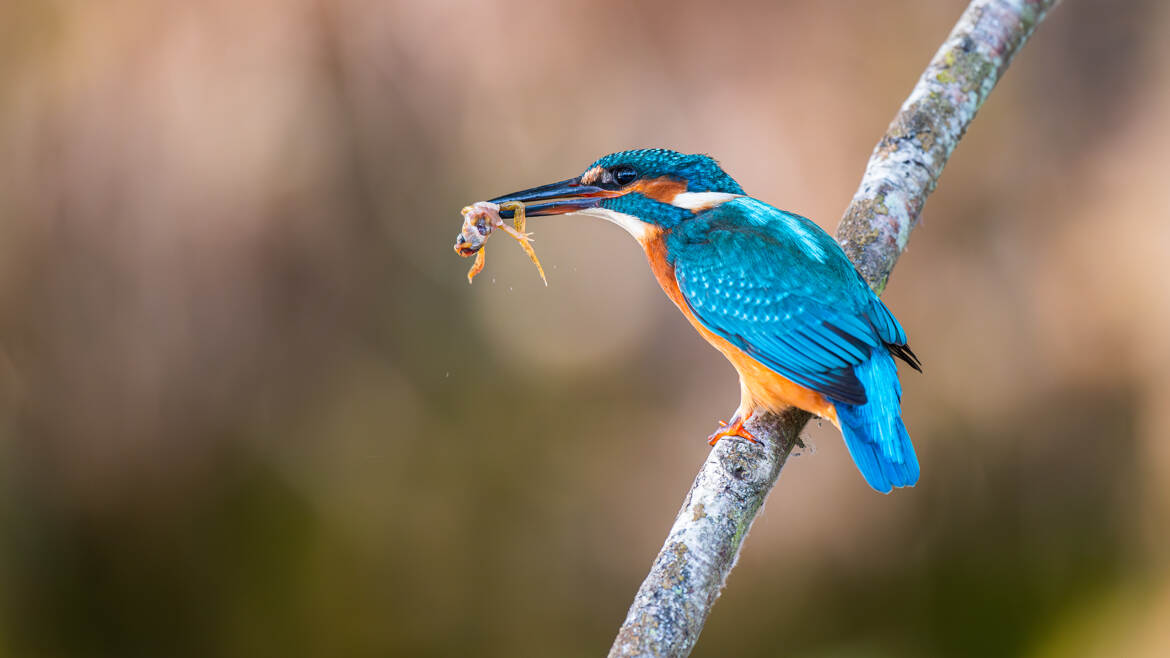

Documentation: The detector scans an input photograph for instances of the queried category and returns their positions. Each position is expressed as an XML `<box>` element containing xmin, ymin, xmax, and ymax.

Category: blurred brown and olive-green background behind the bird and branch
<box><xmin>0</xmin><ymin>0</ymin><xmax>1170</xmax><ymax>657</ymax></box>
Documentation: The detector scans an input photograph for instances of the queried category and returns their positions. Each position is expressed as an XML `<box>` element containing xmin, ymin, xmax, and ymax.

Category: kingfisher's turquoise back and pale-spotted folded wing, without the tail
<box><xmin>670</xmin><ymin>199</ymin><xmax>906</xmax><ymax>405</ymax></box>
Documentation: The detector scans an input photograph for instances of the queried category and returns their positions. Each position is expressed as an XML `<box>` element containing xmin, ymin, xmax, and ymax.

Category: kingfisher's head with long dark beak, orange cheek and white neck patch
<box><xmin>491</xmin><ymin>149</ymin><xmax>743</xmax><ymax>238</ymax></box>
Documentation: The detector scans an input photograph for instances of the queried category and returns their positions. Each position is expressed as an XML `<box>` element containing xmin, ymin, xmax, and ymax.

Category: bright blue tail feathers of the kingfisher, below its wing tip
<box><xmin>837</xmin><ymin>348</ymin><xmax>918</xmax><ymax>493</ymax></box>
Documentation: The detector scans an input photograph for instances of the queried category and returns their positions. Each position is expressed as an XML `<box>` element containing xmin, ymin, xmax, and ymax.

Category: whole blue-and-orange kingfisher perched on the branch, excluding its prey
<box><xmin>479</xmin><ymin>149</ymin><xmax>922</xmax><ymax>493</ymax></box>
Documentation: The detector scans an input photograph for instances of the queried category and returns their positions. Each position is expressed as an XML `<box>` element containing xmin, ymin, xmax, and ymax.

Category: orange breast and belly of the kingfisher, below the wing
<box><xmin>639</xmin><ymin>229</ymin><xmax>837</xmax><ymax>425</ymax></box>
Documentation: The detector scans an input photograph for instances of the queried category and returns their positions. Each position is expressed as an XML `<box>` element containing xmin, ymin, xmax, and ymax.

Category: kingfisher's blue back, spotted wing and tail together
<box><xmin>665</xmin><ymin>197</ymin><xmax>918</xmax><ymax>492</ymax></box>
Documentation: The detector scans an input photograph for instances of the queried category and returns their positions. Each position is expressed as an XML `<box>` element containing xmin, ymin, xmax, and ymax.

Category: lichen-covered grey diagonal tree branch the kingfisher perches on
<box><xmin>610</xmin><ymin>0</ymin><xmax>1059</xmax><ymax>657</ymax></box>
